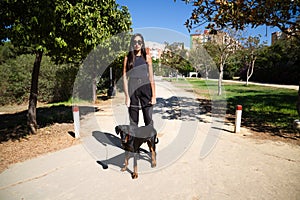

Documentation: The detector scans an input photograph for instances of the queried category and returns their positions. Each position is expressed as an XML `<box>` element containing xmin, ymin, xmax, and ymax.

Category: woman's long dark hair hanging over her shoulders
<box><xmin>126</xmin><ymin>33</ymin><xmax>147</xmax><ymax>71</ymax></box>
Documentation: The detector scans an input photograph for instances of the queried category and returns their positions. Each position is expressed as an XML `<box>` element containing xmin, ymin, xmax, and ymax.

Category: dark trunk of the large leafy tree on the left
<box><xmin>27</xmin><ymin>51</ymin><xmax>43</xmax><ymax>134</ymax></box>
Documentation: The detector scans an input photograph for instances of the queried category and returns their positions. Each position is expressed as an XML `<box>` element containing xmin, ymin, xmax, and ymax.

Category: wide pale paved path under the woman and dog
<box><xmin>0</xmin><ymin>77</ymin><xmax>300</xmax><ymax>200</ymax></box>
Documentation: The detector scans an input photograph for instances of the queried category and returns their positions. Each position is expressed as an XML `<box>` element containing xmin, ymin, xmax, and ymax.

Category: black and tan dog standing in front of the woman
<box><xmin>115</xmin><ymin>125</ymin><xmax>158</xmax><ymax>179</ymax></box>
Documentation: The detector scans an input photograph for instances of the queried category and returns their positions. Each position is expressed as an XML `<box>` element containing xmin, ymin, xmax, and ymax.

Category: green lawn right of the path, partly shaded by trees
<box><xmin>184</xmin><ymin>79</ymin><xmax>299</xmax><ymax>135</ymax></box>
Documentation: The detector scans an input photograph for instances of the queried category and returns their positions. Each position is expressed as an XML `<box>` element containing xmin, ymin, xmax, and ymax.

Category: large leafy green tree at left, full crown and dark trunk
<box><xmin>0</xmin><ymin>0</ymin><xmax>131</xmax><ymax>133</ymax></box>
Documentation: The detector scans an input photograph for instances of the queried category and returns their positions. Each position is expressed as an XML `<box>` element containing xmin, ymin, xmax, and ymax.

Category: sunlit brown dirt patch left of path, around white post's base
<box><xmin>0</xmin><ymin>123</ymin><xmax>80</xmax><ymax>172</ymax></box>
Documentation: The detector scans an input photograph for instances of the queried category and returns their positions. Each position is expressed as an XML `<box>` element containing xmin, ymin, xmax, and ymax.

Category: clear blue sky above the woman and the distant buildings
<box><xmin>116</xmin><ymin>0</ymin><xmax>278</xmax><ymax>46</ymax></box>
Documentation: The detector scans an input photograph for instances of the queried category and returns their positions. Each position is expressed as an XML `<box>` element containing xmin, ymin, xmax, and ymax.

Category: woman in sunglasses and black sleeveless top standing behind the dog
<box><xmin>123</xmin><ymin>33</ymin><xmax>156</xmax><ymax>126</ymax></box>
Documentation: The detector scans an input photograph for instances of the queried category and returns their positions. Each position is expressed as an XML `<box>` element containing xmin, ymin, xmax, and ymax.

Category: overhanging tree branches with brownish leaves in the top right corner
<box><xmin>179</xmin><ymin>0</ymin><xmax>300</xmax><ymax>39</ymax></box>
